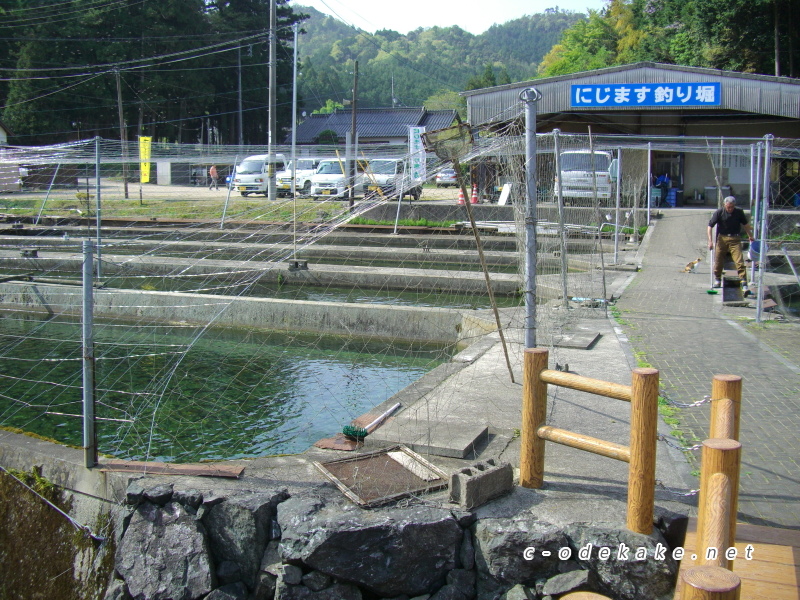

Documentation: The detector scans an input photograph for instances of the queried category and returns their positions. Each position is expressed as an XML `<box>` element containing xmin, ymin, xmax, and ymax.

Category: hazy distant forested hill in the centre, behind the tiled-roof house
<box><xmin>298</xmin><ymin>7</ymin><xmax>586</xmax><ymax>110</ymax></box>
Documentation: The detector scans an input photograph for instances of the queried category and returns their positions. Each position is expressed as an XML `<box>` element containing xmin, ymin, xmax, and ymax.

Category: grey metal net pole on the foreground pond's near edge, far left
<box><xmin>82</xmin><ymin>240</ymin><xmax>97</xmax><ymax>469</ymax></box>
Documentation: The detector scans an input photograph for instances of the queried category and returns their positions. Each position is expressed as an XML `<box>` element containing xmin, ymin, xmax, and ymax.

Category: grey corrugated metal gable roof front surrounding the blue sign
<box><xmin>462</xmin><ymin>62</ymin><xmax>800</xmax><ymax>125</ymax></box>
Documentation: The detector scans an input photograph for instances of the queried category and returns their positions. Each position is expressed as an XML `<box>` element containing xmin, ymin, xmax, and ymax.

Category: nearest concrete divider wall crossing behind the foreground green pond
<box><xmin>0</xmin><ymin>282</ymin><xmax>494</xmax><ymax>345</ymax></box>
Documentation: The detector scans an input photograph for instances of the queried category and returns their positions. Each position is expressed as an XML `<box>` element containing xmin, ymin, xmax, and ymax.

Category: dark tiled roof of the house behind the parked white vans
<box><xmin>290</xmin><ymin>107</ymin><xmax>456</xmax><ymax>144</ymax></box>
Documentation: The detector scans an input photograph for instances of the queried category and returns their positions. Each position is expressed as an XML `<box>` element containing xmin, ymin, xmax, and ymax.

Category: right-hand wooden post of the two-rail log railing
<box><xmin>627</xmin><ymin>369</ymin><xmax>658</xmax><ymax>535</ymax></box>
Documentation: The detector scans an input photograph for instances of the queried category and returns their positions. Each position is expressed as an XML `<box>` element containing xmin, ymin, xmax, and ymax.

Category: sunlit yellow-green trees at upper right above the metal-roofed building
<box><xmin>539</xmin><ymin>0</ymin><xmax>800</xmax><ymax>77</ymax></box>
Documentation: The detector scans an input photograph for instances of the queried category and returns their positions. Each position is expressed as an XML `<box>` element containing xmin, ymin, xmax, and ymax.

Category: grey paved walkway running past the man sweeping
<box><xmin>617</xmin><ymin>209</ymin><xmax>800</xmax><ymax>528</ymax></box>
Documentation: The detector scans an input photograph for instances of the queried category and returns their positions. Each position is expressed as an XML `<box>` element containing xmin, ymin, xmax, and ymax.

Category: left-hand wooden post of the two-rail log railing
<box><xmin>519</xmin><ymin>348</ymin><xmax>549</xmax><ymax>488</ymax></box>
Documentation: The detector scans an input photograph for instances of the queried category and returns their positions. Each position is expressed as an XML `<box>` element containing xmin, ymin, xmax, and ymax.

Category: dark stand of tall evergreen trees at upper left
<box><xmin>0</xmin><ymin>0</ymin><xmax>303</xmax><ymax>143</ymax></box>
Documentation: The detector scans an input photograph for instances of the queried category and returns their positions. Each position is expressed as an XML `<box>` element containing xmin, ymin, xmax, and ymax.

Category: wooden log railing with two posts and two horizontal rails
<box><xmin>519</xmin><ymin>348</ymin><xmax>658</xmax><ymax>535</ymax></box>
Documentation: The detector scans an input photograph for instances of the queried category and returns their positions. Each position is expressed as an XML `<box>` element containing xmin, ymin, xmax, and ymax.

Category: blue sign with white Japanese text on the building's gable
<box><xmin>571</xmin><ymin>82</ymin><xmax>722</xmax><ymax>107</ymax></box>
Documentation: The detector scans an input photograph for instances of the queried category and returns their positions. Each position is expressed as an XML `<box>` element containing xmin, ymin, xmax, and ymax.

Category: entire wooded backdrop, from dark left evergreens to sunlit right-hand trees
<box><xmin>0</xmin><ymin>0</ymin><xmax>800</xmax><ymax>144</ymax></box>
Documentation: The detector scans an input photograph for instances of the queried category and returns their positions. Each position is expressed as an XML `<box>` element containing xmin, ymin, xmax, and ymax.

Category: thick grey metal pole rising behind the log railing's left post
<box><xmin>519</xmin><ymin>88</ymin><xmax>542</xmax><ymax>348</ymax></box>
